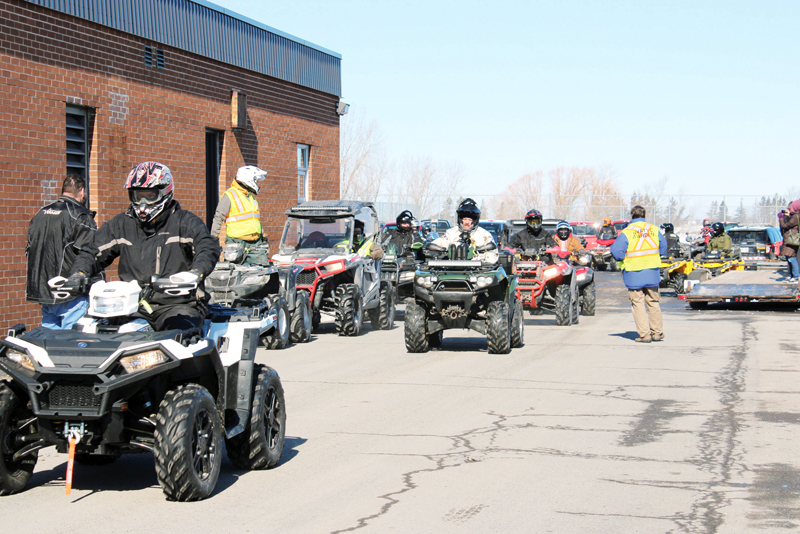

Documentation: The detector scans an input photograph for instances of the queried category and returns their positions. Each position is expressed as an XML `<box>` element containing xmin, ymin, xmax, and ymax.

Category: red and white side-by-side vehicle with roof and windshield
<box><xmin>272</xmin><ymin>200</ymin><xmax>395</xmax><ymax>336</ymax></box>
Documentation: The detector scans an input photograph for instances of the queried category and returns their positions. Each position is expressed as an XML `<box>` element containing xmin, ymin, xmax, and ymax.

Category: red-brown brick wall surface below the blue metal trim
<box><xmin>0</xmin><ymin>0</ymin><xmax>339</xmax><ymax>331</ymax></box>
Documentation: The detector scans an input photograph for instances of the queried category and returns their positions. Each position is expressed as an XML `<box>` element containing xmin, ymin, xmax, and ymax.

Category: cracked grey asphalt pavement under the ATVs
<box><xmin>0</xmin><ymin>273</ymin><xmax>800</xmax><ymax>534</ymax></box>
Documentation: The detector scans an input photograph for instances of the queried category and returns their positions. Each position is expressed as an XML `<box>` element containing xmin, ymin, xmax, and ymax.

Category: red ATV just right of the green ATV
<box><xmin>517</xmin><ymin>248</ymin><xmax>596</xmax><ymax>326</ymax></box>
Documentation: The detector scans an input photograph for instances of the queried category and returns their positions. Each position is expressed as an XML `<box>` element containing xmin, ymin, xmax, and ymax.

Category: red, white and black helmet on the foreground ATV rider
<box><xmin>125</xmin><ymin>161</ymin><xmax>173</xmax><ymax>222</ymax></box>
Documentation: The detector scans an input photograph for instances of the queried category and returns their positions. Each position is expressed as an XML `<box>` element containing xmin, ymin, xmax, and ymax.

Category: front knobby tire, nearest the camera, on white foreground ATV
<box><xmin>153</xmin><ymin>384</ymin><xmax>222</xmax><ymax>501</ymax></box>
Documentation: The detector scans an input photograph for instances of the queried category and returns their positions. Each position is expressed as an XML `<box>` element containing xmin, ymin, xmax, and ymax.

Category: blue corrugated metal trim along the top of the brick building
<box><xmin>27</xmin><ymin>0</ymin><xmax>342</xmax><ymax>96</ymax></box>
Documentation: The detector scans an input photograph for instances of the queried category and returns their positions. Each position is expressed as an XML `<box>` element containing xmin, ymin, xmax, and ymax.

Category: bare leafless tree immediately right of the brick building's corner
<box><xmin>339</xmin><ymin>112</ymin><xmax>391</xmax><ymax>200</ymax></box>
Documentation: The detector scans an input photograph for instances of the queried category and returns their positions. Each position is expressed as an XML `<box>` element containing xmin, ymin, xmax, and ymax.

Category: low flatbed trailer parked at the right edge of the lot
<box><xmin>685</xmin><ymin>270</ymin><xmax>800</xmax><ymax>308</ymax></box>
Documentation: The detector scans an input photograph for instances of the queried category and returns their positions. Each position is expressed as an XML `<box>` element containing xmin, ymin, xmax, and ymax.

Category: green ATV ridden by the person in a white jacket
<box><xmin>405</xmin><ymin>243</ymin><xmax>524</xmax><ymax>354</ymax></box>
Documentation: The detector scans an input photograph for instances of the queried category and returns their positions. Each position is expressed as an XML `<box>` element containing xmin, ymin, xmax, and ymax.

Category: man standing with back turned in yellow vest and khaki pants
<box><xmin>611</xmin><ymin>206</ymin><xmax>667</xmax><ymax>343</ymax></box>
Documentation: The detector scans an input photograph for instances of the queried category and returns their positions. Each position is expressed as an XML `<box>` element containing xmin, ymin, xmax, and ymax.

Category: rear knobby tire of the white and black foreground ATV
<box><xmin>225</xmin><ymin>365</ymin><xmax>286</xmax><ymax>469</ymax></box>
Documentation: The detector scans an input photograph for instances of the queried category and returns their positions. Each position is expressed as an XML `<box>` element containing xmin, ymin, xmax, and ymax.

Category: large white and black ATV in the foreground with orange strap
<box><xmin>0</xmin><ymin>275</ymin><xmax>288</xmax><ymax>501</ymax></box>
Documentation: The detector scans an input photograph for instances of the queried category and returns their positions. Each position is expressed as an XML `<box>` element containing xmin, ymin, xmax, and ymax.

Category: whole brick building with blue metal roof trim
<box><xmin>0</xmin><ymin>0</ymin><xmax>341</xmax><ymax>331</ymax></box>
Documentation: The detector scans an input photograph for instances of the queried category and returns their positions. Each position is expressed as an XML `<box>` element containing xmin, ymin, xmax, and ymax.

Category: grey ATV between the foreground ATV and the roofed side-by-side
<box><xmin>205</xmin><ymin>243</ymin><xmax>311</xmax><ymax>348</ymax></box>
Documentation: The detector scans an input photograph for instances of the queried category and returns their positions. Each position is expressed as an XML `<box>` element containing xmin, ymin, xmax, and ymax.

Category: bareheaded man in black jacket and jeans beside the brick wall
<box><xmin>25</xmin><ymin>174</ymin><xmax>97</xmax><ymax>329</ymax></box>
